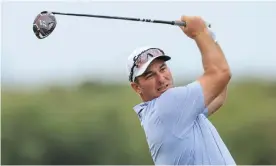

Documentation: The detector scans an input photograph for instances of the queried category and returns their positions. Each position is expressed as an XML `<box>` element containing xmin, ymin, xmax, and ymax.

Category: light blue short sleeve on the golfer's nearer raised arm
<box><xmin>156</xmin><ymin>81</ymin><xmax>208</xmax><ymax>135</ymax></box>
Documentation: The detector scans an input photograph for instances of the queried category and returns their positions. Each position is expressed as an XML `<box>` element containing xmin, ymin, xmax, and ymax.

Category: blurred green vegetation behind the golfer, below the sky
<box><xmin>1</xmin><ymin>80</ymin><xmax>276</xmax><ymax>165</ymax></box>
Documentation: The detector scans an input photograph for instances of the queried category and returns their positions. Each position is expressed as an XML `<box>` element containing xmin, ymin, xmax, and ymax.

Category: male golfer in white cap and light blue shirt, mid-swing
<box><xmin>128</xmin><ymin>16</ymin><xmax>236</xmax><ymax>165</ymax></box>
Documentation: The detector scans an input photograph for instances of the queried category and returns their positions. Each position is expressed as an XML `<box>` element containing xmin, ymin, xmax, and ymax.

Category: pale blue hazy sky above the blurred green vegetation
<box><xmin>1</xmin><ymin>1</ymin><xmax>276</xmax><ymax>85</ymax></box>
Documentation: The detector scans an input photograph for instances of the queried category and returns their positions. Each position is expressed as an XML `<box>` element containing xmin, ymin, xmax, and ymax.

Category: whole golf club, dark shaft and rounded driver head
<box><xmin>33</xmin><ymin>11</ymin><xmax>211</xmax><ymax>39</ymax></box>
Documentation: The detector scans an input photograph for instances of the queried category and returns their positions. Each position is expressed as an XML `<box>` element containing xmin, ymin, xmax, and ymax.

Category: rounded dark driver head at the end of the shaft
<box><xmin>33</xmin><ymin>11</ymin><xmax>57</xmax><ymax>39</ymax></box>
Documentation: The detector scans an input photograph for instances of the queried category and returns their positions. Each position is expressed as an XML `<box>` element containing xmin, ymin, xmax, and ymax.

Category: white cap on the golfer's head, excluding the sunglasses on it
<box><xmin>127</xmin><ymin>46</ymin><xmax>171</xmax><ymax>82</ymax></box>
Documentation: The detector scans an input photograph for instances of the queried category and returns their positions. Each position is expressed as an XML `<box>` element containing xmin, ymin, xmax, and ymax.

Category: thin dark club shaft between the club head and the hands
<box><xmin>52</xmin><ymin>12</ymin><xmax>186</xmax><ymax>26</ymax></box>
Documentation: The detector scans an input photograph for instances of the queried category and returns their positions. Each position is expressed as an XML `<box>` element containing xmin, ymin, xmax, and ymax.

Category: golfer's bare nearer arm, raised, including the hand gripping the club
<box><xmin>181</xmin><ymin>16</ymin><xmax>231</xmax><ymax>111</ymax></box>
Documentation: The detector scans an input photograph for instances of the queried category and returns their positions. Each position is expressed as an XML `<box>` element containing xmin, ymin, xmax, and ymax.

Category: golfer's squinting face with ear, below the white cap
<box><xmin>131</xmin><ymin>59</ymin><xmax>173</xmax><ymax>101</ymax></box>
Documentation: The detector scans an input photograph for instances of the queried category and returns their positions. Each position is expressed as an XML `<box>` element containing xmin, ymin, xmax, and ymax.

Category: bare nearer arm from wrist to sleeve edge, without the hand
<box><xmin>195</xmin><ymin>27</ymin><xmax>231</xmax><ymax>106</ymax></box>
